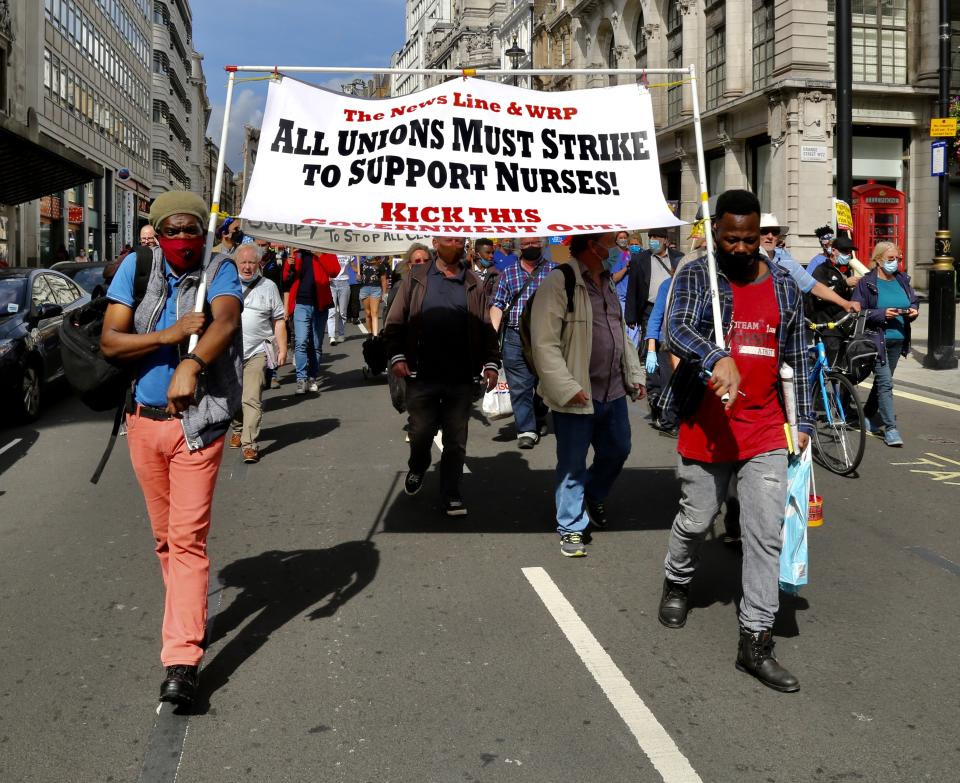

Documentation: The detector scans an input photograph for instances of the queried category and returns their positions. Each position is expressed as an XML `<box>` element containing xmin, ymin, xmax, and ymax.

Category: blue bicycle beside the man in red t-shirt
<box><xmin>804</xmin><ymin>313</ymin><xmax>867</xmax><ymax>476</ymax></box>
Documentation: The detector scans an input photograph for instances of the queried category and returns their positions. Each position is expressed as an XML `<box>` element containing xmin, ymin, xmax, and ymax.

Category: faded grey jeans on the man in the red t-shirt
<box><xmin>663</xmin><ymin>449</ymin><xmax>787</xmax><ymax>631</ymax></box>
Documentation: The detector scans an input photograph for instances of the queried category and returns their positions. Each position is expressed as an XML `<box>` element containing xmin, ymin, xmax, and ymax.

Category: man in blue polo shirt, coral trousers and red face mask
<box><xmin>101</xmin><ymin>191</ymin><xmax>243</xmax><ymax>704</ymax></box>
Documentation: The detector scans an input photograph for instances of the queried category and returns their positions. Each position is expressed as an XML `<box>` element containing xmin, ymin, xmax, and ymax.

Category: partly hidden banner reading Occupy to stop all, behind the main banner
<box><xmin>243</xmin><ymin>220</ymin><xmax>432</xmax><ymax>256</ymax></box>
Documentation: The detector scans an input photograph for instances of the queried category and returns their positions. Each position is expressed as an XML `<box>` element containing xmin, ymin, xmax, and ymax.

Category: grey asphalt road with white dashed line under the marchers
<box><xmin>0</xmin><ymin>338</ymin><xmax>960</xmax><ymax>783</ymax></box>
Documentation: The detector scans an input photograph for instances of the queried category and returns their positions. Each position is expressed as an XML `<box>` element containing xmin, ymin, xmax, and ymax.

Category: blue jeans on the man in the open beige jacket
<box><xmin>553</xmin><ymin>397</ymin><xmax>630</xmax><ymax>535</ymax></box>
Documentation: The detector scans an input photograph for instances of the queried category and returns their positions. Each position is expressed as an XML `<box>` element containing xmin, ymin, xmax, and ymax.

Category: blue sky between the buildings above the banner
<box><xmin>191</xmin><ymin>0</ymin><xmax>405</xmax><ymax>171</ymax></box>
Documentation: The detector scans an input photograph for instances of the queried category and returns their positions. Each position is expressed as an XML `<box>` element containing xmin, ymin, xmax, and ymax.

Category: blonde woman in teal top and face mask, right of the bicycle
<box><xmin>853</xmin><ymin>242</ymin><xmax>920</xmax><ymax>446</ymax></box>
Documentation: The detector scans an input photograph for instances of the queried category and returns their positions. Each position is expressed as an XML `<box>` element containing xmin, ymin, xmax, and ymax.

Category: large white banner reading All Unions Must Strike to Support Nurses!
<box><xmin>241</xmin><ymin>78</ymin><xmax>682</xmax><ymax>237</ymax></box>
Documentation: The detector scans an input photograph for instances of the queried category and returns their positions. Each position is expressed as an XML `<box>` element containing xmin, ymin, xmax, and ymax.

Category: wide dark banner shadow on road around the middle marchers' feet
<box><xmin>383</xmin><ymin>451</ymin><xmax>680</xmax><ymax>533</ymax></box>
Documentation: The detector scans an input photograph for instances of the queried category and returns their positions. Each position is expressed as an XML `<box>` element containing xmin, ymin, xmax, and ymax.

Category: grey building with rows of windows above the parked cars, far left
<box><xmin>0</xmin><ymin>0</ymin><xmax>210</xmax><ymax>266</ymax></box>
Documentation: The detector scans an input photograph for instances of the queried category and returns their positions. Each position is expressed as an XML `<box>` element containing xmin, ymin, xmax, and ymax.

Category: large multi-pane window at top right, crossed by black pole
<box><xmin>827</xmin><ymin>0</ymin><xmax>907</xmax><ymax>84</ymax></box>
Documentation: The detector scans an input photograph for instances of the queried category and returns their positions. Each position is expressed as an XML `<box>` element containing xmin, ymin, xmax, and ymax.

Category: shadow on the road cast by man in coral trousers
<box><xmin>193</xmin><ymin>540</ymin><xmax>380</xmax><ymax>715</ymax></box>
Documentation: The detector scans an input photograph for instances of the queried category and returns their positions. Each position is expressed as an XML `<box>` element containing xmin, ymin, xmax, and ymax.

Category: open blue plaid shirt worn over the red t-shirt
<box><xmin>660</xmin><ymin>257</ymin><xmax>813</xmax><ymax>435</ymax></box>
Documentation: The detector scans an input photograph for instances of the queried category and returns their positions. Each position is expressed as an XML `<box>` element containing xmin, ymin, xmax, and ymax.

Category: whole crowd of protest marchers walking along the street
<box><xmin>90</xmin><ymin>185</ymin><xmax>918</xmax><ymax>704</ymax></box>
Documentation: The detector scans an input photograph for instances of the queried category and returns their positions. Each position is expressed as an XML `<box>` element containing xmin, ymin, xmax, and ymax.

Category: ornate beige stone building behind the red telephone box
<box><xmin>534</xmin><ymin>0</ymin><xmax>960</xmax><ymax>287</ymax></box>
